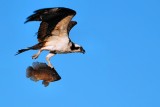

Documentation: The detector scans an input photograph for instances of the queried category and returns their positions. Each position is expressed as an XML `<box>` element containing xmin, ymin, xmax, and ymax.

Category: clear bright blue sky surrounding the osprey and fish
<box><xmin>0</xmin><ymin>0</ymin><xmax>160</xmax><ymax>107</ymax></box>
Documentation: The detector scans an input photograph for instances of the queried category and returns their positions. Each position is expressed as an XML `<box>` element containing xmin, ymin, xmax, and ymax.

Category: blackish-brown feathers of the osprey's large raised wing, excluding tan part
<box><xmin>25</xmin><ymin>7</ymin><xmax>76</xmax><ymax>41</ymax></box>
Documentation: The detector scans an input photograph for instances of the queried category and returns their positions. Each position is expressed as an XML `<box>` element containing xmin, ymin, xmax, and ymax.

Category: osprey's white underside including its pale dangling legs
<box><xmin>32</xmin><ymin>33</ymin><xmax>80</xmax><ymax>68</ymax></box>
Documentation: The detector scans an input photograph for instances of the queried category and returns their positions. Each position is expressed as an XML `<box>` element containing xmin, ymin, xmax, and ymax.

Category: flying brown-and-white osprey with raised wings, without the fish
<box><xmin>16</xmin><ymin>7</ymin><xmax>85</xmax><ymax>68</ymax></box>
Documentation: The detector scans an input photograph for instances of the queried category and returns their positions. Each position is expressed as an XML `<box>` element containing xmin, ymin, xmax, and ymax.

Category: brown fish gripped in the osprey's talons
<box><xmin>26</xmin><ymin>62</ymin><xmax>61</xmax><ymax>87</ymax></box>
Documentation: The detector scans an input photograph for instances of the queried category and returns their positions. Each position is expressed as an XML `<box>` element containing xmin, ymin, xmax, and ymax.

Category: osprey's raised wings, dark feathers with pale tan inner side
<box><xmin>25</xmin><ymin>7</ymin><xmax>76</xmax><ymax>42</ymax></box>
